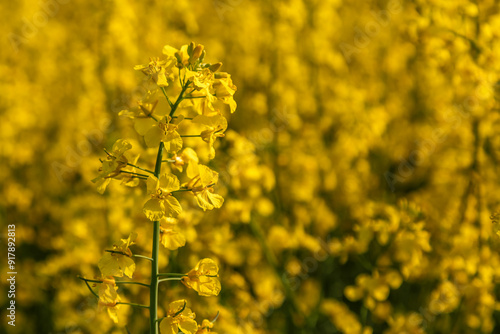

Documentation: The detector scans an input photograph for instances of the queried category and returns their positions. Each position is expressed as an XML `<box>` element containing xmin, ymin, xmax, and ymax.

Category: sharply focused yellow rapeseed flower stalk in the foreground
<box><xmin>82</xmin><ymin>43</ymin><xmax>236</xmax><ymax>334</ymax></box>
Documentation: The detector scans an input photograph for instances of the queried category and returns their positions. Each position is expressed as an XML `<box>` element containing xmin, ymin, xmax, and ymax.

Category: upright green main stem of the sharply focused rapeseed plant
<box><xmin>149</xmin><ymin>142</ymin><xmax>164</xmax><ymax>334</ymax></box>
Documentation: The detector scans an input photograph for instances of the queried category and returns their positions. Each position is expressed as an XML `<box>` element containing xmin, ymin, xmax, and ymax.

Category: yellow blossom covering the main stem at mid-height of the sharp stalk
<box><xmin>143</xmin><ymin>174</ymin><xmax>182</xmax><ymax>221</ymax></box>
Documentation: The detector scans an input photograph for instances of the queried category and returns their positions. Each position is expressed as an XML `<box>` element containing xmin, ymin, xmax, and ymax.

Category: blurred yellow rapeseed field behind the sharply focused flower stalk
<box><xmin>0</xmin><ymin>0</ymin><xmax>500</xmax><ymax>334</ymax></box>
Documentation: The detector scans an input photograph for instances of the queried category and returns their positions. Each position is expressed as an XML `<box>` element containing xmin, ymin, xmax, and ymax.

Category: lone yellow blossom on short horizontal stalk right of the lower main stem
<box><xmin>181</xmin><ymin>258</ymin><xmax>221</xmax><ymax>296</ymax></box>
